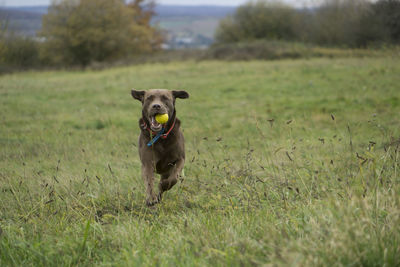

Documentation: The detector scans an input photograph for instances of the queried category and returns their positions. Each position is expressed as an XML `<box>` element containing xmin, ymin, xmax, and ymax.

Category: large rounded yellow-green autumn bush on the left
<box><xmin>41</xmin><ymin>0</ymin><xmax>161</xmax><ymax>65</ymax></box>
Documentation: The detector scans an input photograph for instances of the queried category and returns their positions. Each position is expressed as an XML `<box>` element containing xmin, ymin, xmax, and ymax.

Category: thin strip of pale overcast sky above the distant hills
<box><xmin>0</xmin><ymin>0</ymin><xmax>305</xmax><ymax>6</ymax></box>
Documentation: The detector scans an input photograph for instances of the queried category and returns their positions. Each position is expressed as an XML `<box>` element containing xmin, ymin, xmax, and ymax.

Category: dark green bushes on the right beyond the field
<box><xmin>215</xmin><ymin>0</ymin><xmax>400</xmax><ymax>48</ymax></box>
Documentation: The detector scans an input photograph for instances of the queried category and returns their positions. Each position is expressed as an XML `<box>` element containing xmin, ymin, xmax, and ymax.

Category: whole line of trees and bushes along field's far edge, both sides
<box><xmin>0</xmin><ymin>0</ymin><xmax>400</xmax><ymax>73</ymax></box>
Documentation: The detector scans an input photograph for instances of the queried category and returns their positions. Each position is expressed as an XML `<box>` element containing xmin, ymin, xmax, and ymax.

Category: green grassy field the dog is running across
<box><xmin>0</xmin><ymin>57</ymin><xmax>400</xmax><ymax>266</ymax></box>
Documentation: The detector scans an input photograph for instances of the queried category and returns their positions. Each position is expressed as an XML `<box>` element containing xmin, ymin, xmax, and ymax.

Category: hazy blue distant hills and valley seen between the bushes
<box><xmin>0</xmin><ymin>5</ymin><xmax>235</xmax><ymax>48</ymax></box>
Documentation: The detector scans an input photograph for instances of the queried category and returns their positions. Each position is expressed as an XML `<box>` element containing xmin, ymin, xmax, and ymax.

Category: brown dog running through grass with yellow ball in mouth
<box><xmin>131</xmin><ymin>89</ymin><xmax>189</xmax><ymax>206</ymax></box>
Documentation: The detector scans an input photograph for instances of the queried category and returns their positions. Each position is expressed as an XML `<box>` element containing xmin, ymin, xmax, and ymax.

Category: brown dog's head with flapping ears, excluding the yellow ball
<box><xmin>131</xmin><ymin>89</ymin><xmax>189</xmax><ymax>132</ymax></box>
